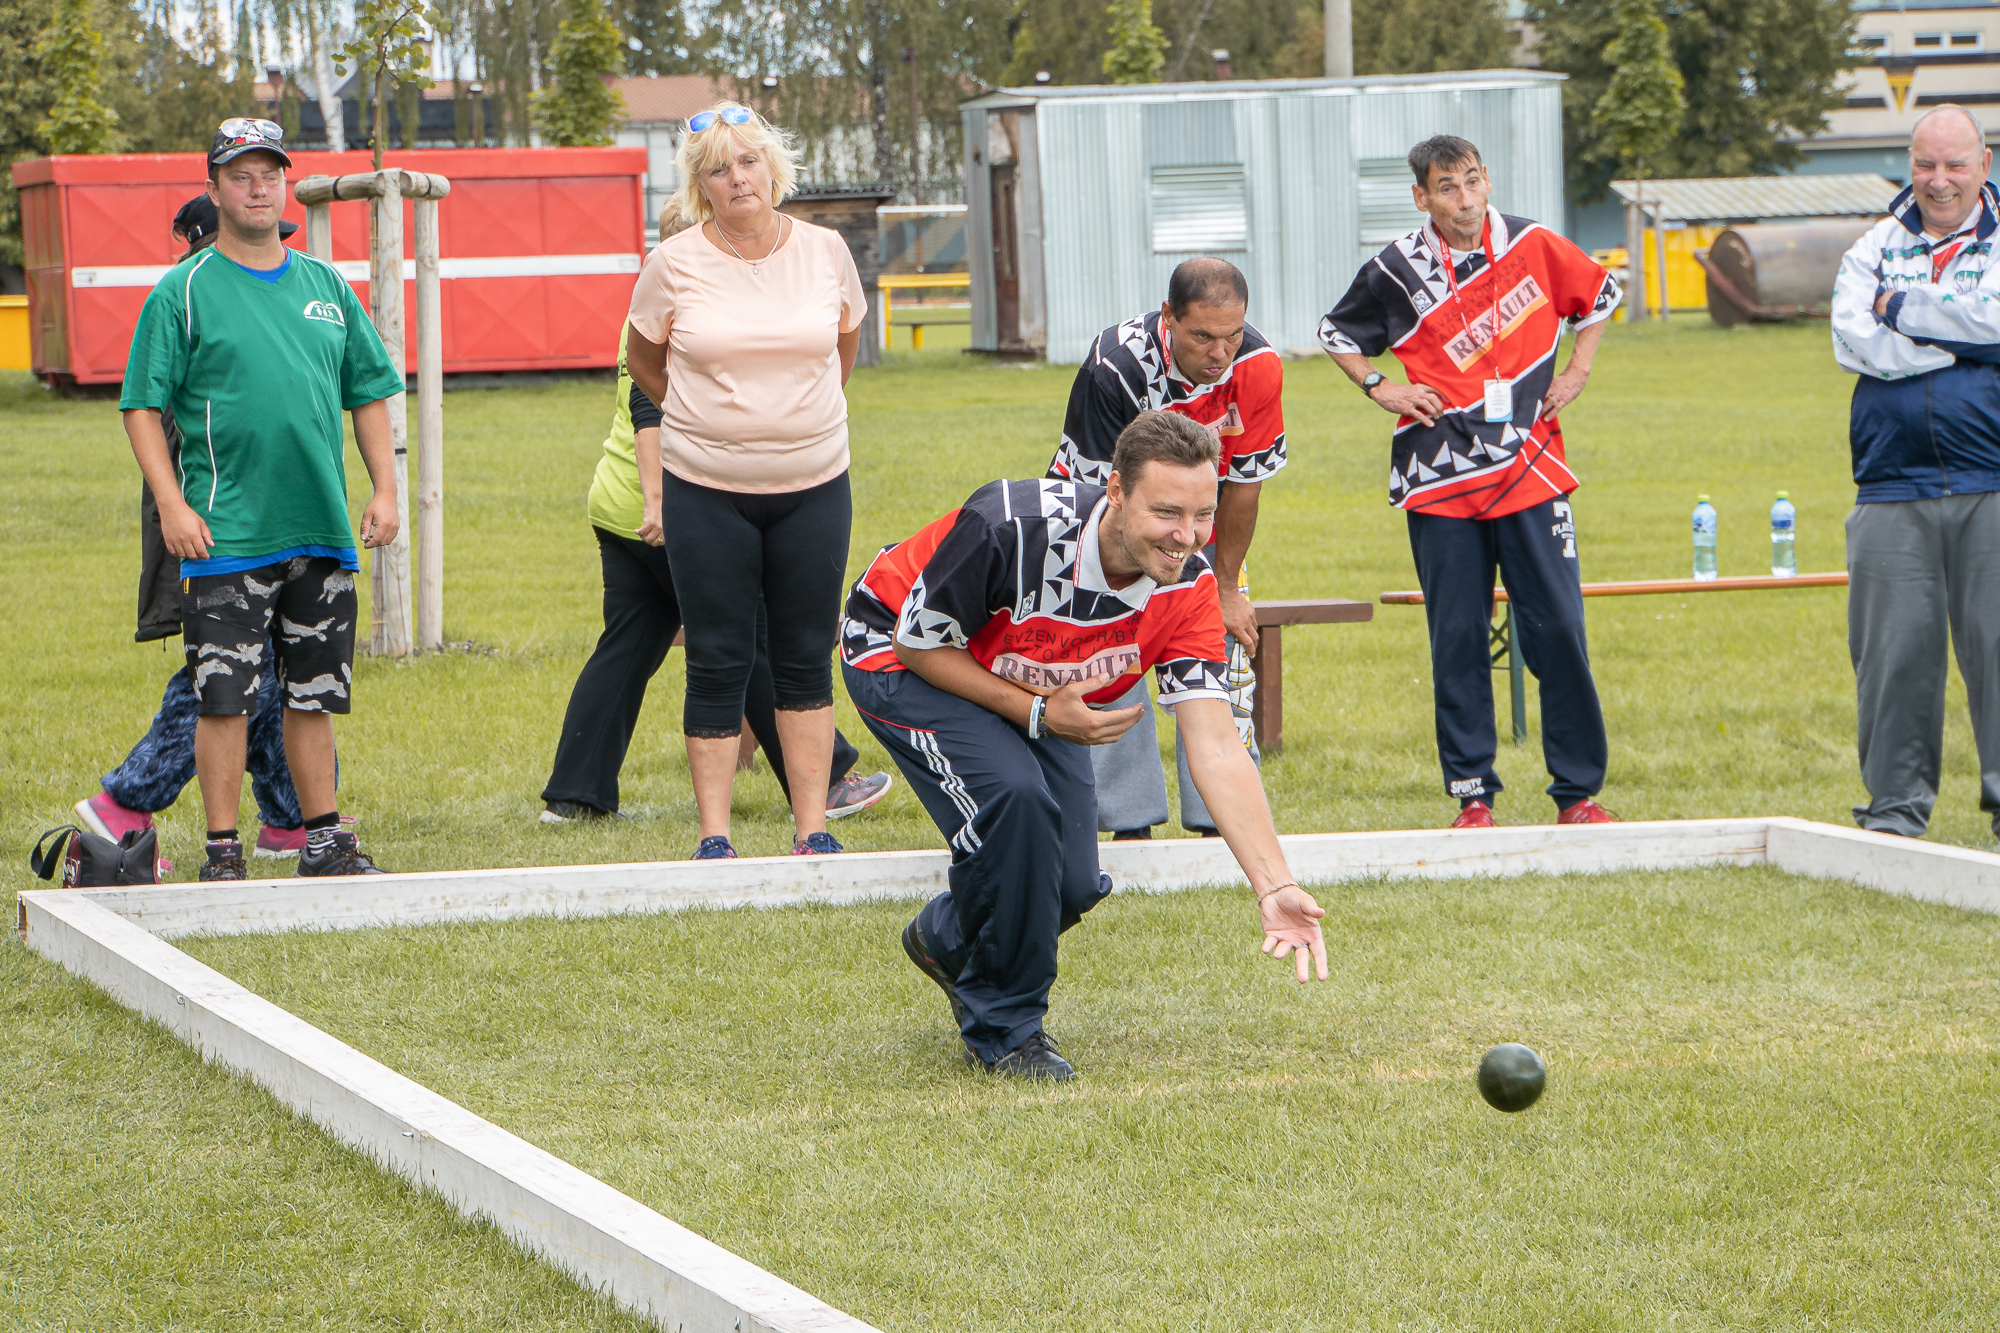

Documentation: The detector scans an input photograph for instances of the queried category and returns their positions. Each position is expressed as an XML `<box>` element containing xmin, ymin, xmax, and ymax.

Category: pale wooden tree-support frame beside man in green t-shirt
<box><xmin>296</xmin><ymin>168</ymin><xmax>452</xmax><ymax>656</ymax></box>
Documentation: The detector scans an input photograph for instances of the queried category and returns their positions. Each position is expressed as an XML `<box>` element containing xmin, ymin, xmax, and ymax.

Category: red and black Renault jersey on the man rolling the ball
<box><xmin>840</xmin><ymin>478</ymin><xmax>1228</xmax><ymax>711</ymax></box>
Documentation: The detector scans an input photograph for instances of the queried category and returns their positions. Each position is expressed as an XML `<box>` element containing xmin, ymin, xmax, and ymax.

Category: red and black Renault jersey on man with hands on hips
<box><xmin>1320</xmin><ymin>208</ymin><xmax>1620</xmax><ymax>518</ymax></box>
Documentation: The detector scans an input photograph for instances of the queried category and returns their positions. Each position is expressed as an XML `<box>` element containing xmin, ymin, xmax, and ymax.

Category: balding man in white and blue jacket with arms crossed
<box><xmin>1834</xmin><ymin>106</ymin><xmax>2000</xmax><ymax>837</ymax></box>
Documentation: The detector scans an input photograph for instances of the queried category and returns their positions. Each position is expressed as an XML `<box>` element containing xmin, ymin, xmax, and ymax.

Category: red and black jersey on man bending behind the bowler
<box><xmin>1048</xmin><ymin>310</ymin><xmax>1284</xmax><ymax>486</ymax></box>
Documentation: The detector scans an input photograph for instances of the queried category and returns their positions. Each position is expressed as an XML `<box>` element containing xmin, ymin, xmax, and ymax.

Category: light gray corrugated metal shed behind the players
<box><xmin>960</xmin><ymin>70</ymin><xmax>1562</xmax><ymax>362</ymax></box>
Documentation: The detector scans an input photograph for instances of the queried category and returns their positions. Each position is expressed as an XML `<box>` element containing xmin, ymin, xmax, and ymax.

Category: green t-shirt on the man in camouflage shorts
<box><xmin>118</xmin><ymin>248</ymin><xmax>404</xmax><ymax>558</ymax></box>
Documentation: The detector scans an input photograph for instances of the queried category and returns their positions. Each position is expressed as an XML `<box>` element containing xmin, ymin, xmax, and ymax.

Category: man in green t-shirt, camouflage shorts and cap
<box><xmin>118</xmin><ymin>118</ymin><xmax>404</xmax><ymax>881</ymax></box>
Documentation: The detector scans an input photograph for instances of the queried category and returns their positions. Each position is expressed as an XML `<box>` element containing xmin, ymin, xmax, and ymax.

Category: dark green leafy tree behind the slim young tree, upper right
<box><xmin>1528</xmin><ymin>0</ymin><xmax>1854</xmax><ymax>204</ymax></box>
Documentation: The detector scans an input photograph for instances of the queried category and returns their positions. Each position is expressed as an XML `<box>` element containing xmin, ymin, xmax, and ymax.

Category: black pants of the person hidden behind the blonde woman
<box><xmin>544</xmin><ymin>528</ymin><xmax>860</xmax><ymax>813</ymax></box>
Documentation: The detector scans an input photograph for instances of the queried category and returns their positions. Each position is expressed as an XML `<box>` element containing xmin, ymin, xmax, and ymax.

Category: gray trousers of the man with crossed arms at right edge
<box><xmin>1848</xmin><ymin>494</ymin><xmax>2000</xmax><ymax>837</ymax></box>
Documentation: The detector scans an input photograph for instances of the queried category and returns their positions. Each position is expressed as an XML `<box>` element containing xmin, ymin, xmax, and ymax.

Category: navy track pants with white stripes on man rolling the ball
<box><xmin>842</xmin><ymin>667</ymin><xmax>1110</xmax><ymax>1061</ymax></box>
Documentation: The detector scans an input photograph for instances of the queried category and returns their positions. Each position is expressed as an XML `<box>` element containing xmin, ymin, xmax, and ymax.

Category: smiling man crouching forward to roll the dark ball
<box><xmin>840</xmin><ymin>412</ymin><xmax>1326</xmax><ymax>1081</ymax></box>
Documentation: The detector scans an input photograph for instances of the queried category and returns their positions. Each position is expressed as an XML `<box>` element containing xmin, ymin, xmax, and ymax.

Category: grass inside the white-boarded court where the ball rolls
<box><xmin>192</xmin><ymin>871</ymin><xmax>2000</xmax><ymax>1333</ymax></box>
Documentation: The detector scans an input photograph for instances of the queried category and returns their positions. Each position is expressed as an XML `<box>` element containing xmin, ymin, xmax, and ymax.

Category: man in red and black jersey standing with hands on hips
<box><xmin>1320</xmin><ymin>134</ymin><xmax>1620</xmax><ymax>829</ymax></box>
